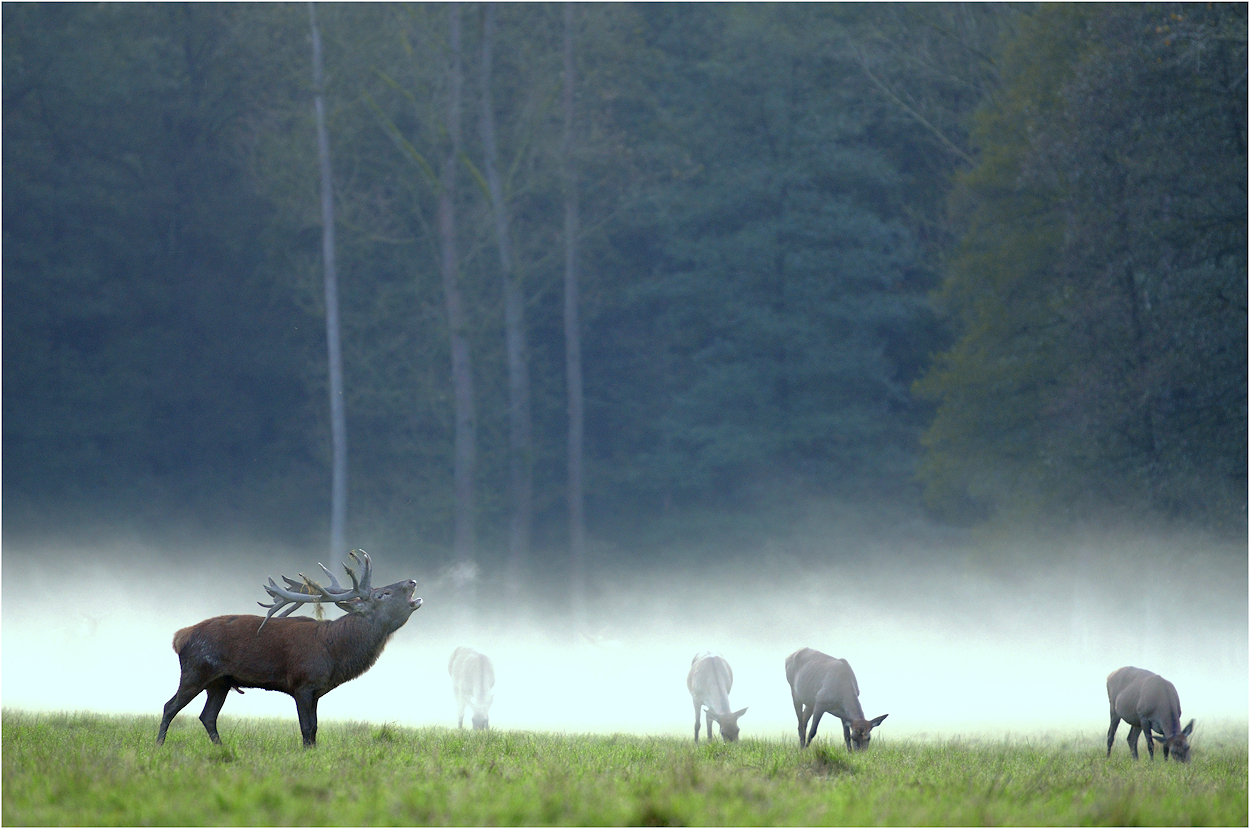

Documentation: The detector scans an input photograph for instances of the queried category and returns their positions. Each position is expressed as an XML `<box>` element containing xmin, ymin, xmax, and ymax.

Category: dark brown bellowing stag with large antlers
<box><xmin>156</xmin><ymin>550</ymin><xmax>421</xmax><ymax>746</ymax></box>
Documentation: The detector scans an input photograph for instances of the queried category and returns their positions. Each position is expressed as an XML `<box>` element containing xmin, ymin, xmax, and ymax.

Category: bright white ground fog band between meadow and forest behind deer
<box><xmin>0</xmin><ymin>520</ymin><xmax>1250</xmax><ymax>745</ymax></box>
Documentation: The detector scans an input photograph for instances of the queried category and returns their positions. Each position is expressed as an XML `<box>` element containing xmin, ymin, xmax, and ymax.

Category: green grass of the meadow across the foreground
<box><xmin>0</xmin><ymin>710</ymin><xmax>1248</xmax><ymax>826</ymax></box>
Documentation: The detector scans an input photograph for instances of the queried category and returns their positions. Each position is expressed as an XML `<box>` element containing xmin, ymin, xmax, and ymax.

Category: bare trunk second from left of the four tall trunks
<box><xmin>439</xmin><ymin>3</ymin><xmax>478</xmax><ymax>597</ymax></box>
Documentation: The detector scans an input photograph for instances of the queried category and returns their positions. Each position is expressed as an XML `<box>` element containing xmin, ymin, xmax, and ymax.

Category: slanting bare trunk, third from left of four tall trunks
<box><xmin>481</xmin><ymin>3</ymin><xmax>534</xmax><ymax>593</ymax></box>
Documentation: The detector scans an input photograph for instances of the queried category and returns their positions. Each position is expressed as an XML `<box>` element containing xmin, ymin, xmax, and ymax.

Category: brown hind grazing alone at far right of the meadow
<box><xmin>1106</xmin><ymin>665</ymin><xmax>1194</xmax><ymax>763</ymax></box>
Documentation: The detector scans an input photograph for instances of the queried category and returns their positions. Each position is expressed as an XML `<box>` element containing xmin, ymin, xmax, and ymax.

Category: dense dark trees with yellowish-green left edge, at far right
<box><xmin>919</xmin><ymin>5</ymin><xmax>1246</xmax><ymax>531</ymax></box>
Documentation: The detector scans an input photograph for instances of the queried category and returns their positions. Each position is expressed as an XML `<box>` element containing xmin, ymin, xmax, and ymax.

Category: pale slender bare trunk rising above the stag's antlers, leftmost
<box><xmin>309</xmin><ymin>3</ymin><xmax>348</xmax><ymax>556</ymax></box>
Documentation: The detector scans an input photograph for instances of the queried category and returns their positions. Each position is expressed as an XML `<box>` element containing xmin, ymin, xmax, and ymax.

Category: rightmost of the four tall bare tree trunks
<box><xmin>560</xmin><ymin>3</ymin><xmax>586</xmax><ymax>629</ymax></box>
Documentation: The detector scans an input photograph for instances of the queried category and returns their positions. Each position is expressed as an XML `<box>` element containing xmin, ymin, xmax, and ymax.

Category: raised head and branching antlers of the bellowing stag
<box><xmin>256</xmin><ymin>550</ymin><xmax>421</xmax><ymax>634</ymax></box>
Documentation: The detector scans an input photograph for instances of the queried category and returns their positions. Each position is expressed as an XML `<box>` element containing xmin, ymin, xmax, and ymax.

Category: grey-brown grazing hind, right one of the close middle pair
<box><xmin>785</xmin><ymin>648</ymin><xmax>889</xmax><ymax>750</ymax></box>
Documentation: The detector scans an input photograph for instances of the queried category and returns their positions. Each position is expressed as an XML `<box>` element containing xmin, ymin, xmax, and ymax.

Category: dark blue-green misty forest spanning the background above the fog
<box><xmin>3</xmin><ymin>4</ymin><xmax>1248</xmax><ymax>575</ymax></box>
